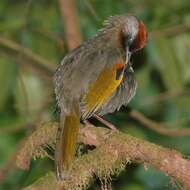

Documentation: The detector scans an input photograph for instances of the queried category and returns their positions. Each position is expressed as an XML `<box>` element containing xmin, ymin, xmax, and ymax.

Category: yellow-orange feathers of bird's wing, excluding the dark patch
<box><xmin>84</xmin><ymin>64</ymin><xmax>123</xmax><ymax>115</ymax></box>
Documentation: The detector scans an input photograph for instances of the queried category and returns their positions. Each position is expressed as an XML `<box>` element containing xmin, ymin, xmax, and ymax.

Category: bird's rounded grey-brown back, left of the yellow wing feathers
<box><xmin>54</xmin><ymin>45</ymin><xmax>121</xmax><ymax>113</ymax></box>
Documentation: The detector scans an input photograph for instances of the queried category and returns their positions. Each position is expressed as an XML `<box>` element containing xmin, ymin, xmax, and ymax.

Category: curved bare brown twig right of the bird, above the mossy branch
<box><xmin>130</xmin><ymin>110</ymin><xmax>190</xmax><ymax>136</ymax></box>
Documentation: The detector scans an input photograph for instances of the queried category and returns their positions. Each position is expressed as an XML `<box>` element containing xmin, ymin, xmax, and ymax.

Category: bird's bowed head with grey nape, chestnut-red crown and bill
<box><xmin>103</xmin><ymin>15</ymin><xmax>148</xmax><ymax>62</ymax></box>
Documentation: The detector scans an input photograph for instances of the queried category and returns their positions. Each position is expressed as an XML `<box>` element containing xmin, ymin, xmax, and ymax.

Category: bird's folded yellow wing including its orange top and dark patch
<box><xmin>80</xmin><ymin>60</ymin><xmax>125</xmax><ymax>120</ymax></box>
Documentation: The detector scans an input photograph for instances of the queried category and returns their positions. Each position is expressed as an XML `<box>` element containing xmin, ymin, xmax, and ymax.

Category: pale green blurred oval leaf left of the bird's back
<box><xmin>15</xmin><ymin>72</ymin><xmax>47</xmax><ymax>122</ymax></box>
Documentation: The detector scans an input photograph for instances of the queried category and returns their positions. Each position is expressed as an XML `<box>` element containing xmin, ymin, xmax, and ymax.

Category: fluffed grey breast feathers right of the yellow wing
<box><xmin>98</xmin><ymin>68</ymin><xmax>137</xmax><ymax>115</ymax></box>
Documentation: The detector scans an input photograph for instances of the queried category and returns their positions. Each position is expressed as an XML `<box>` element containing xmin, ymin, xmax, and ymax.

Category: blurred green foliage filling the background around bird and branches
<box><xmin>0</xmin><ymin>0</ymin><xmax>190</xmax><ymax>190</ymax></box>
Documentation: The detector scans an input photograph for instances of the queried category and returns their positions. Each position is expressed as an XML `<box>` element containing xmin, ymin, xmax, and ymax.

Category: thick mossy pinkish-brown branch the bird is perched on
<box><xmin>17</xmin><ymin>123</ymin><xmax>190</xmax><ymax>190</ymax></box>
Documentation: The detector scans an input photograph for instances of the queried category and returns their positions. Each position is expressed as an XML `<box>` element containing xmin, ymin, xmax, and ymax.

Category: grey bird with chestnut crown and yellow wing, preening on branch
<box><xmin>53</xmin><ymin>14</ymin><xmax>148</xmax><ymax>180</ymax></box>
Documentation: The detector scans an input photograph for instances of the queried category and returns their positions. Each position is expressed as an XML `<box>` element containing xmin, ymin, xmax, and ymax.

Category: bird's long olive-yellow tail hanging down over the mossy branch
<box><xmin>55</xmin><ymin>108</ymin><xmax>80</xmax><ymax>180</ymax></box>
